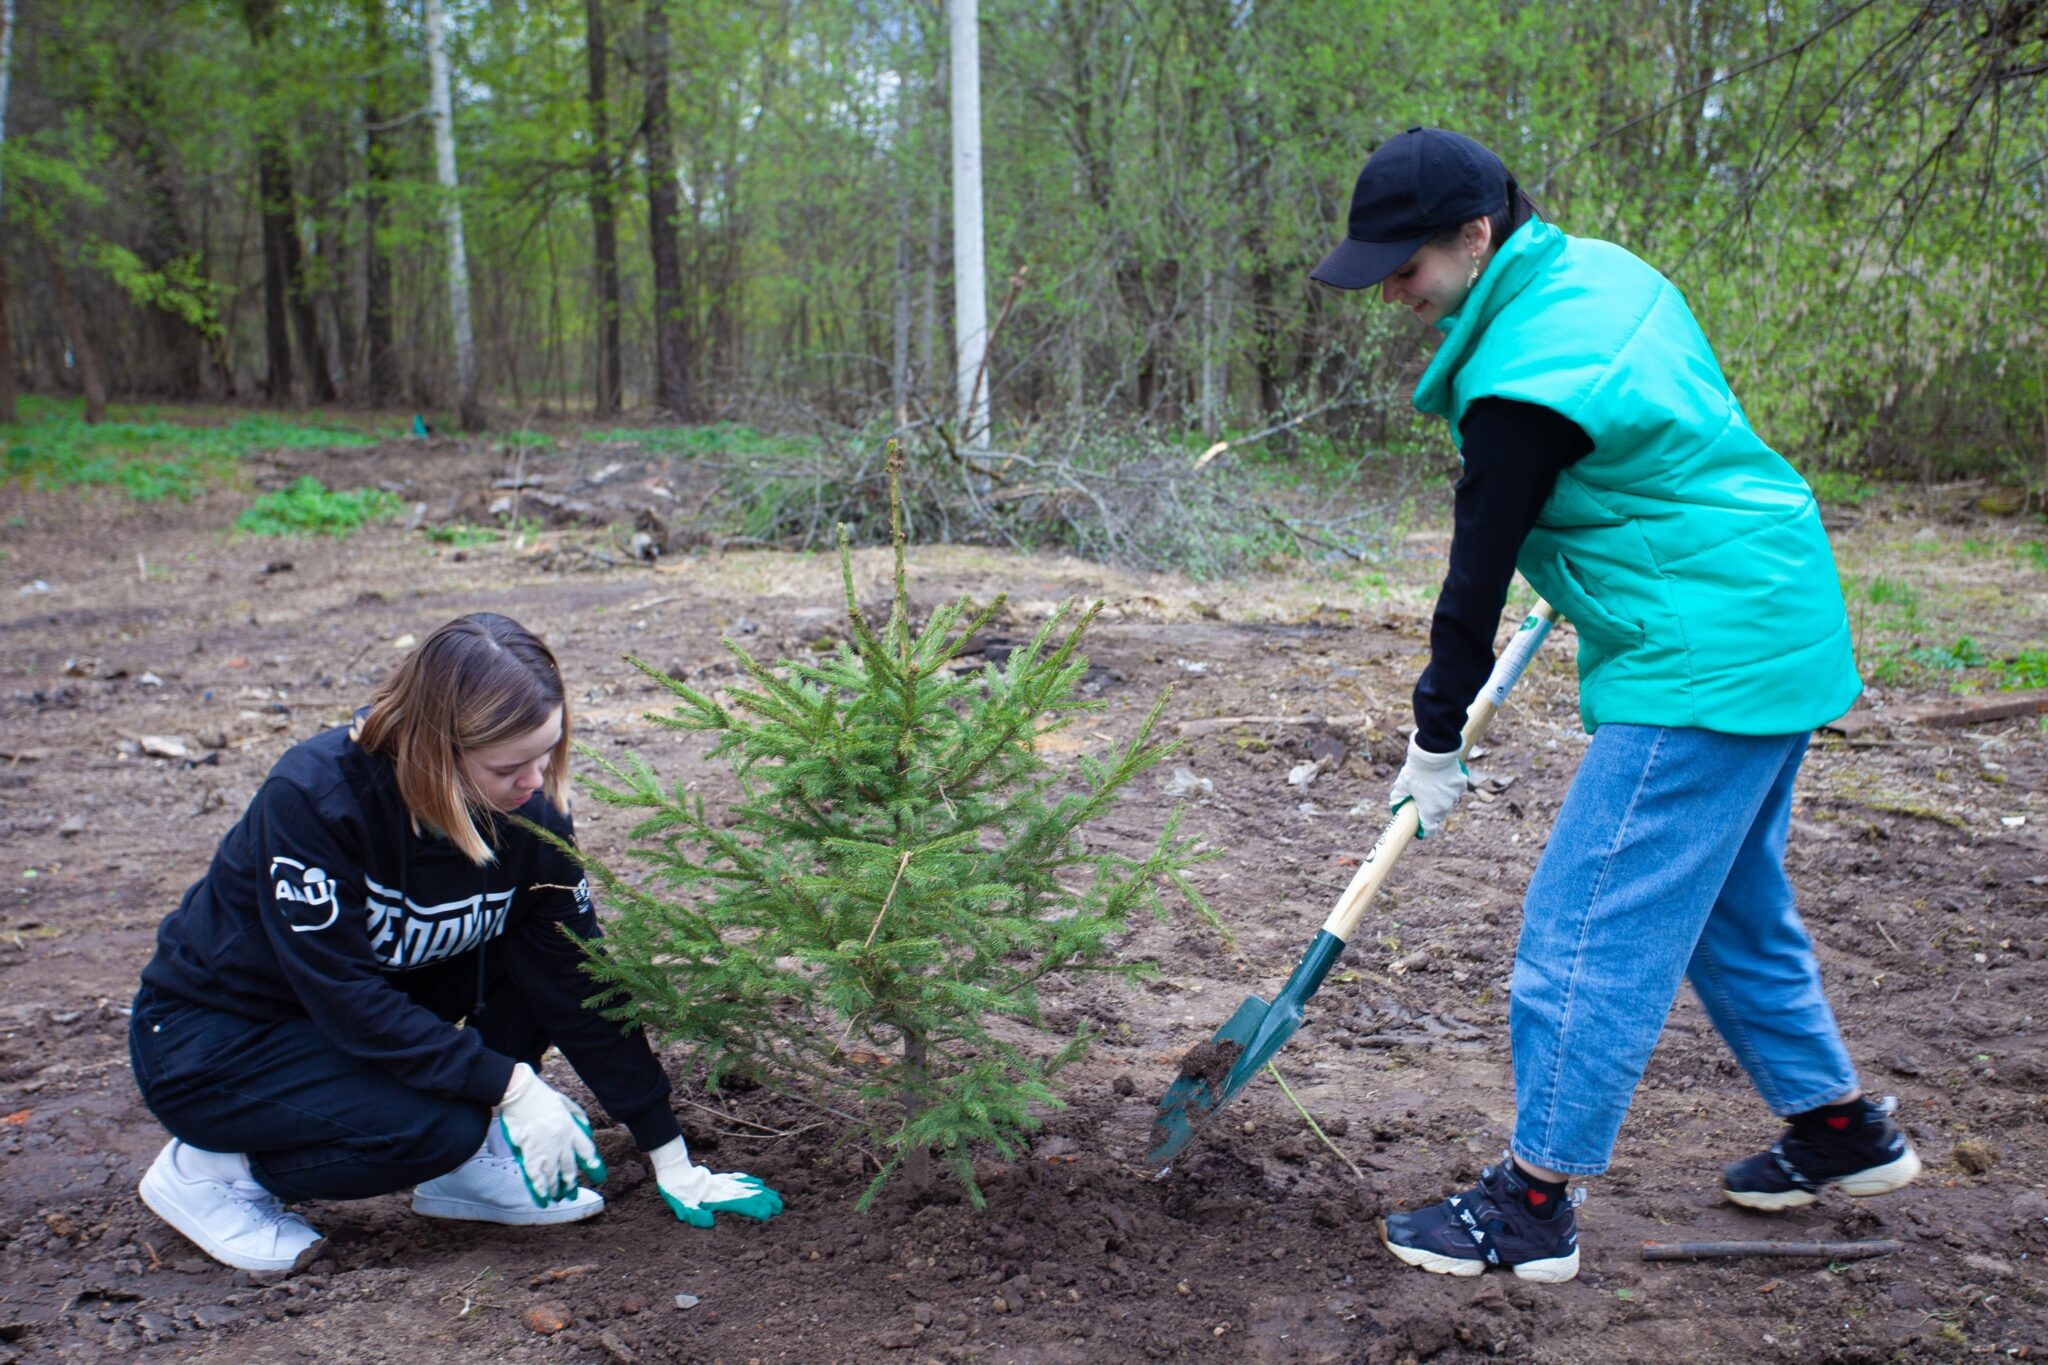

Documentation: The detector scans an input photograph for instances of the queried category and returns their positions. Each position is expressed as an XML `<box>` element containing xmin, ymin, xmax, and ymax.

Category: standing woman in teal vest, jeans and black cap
<box><xmin>1311</xmin><ymin>127</ymin><xmax>1919</xmax><ymax>1281</ymax></box>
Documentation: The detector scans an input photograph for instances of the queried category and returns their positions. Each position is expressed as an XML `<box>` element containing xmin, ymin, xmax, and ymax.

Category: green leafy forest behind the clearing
<box><xmin>0</xmin><ymin>0</ymin><xmax>2048</xmax><ymax>495</ymax></box>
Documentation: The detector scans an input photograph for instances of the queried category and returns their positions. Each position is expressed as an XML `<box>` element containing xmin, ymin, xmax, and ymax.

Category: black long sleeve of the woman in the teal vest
<box><xmin>1415</xmin><ymin>399</ymin><xmax>1593</xmax><ymax>753</ymax></box>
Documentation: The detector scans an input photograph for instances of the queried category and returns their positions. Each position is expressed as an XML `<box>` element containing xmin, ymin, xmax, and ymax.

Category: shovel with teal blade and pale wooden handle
<box><xmin>1145</xmin><ymin>598</ymin><xmax>1559</xmax><ymax>1175</ymax></box>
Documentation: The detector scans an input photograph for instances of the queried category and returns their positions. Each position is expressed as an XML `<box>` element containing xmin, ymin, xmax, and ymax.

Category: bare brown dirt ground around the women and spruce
<box><xmin>0</xmin><ymin>442</ymin><xmax>2048</xmax><ymax>1365</ymax></box>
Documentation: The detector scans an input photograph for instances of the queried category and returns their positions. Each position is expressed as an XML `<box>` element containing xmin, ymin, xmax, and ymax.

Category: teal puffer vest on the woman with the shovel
<box><xmin>1415</xmin><ymin>221</ymin><xmax>1864</xmax><ymax>735</ymax></box>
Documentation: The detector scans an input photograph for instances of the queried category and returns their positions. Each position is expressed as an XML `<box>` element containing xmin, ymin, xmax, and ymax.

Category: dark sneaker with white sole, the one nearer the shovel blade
<box><xmin>1380</xmin><ymin>1156</ymin><xmax>1585</xmax><ymax>1285</ymax></box>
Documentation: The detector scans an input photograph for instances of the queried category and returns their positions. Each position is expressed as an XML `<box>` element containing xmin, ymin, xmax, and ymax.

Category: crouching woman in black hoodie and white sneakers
<box><xmin>129</xmin><ymin>614</ymin><xmax>782</xmax><ymax>1271</ymax></box>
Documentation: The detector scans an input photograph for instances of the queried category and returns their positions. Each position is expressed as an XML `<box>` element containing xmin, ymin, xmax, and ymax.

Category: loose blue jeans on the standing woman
<box><xmin>1509</xmin><ymin>724</ymin><xmax>1858</xmax><ymax>1175</ymax></box>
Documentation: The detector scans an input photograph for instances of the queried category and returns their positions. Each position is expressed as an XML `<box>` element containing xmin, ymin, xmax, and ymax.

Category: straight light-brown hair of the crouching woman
<box><xmin>356</xmin><ymin>612</ymin><xmax>569</xmax><ymax>868</ymax></box>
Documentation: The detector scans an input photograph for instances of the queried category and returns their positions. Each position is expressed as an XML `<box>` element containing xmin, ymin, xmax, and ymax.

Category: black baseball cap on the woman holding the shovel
<box><xmin>1309</xmin><ymin>127</ymin><xmax>1513</xmax><ymax>289</ymax></box>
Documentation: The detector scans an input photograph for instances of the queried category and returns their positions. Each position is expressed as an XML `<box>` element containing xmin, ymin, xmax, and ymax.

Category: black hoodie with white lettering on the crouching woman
<box><xmin>141</xmin><ymin>729</ymin><xmax>680</xmax><ymax>1150</ymax></box>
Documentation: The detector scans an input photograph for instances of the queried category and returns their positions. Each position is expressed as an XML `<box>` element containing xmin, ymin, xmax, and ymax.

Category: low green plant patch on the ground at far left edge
<box><xmin>0</xmin><ymin>397</ymin><xmax>373</xmax><ymax>501</ymax></box>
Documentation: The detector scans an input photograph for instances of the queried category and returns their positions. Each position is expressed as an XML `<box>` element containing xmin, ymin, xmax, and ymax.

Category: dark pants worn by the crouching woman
<box><xmin>129</xmin><ymin>954</ymin><xmax>549</xmax><ymax>1199</ymax></box>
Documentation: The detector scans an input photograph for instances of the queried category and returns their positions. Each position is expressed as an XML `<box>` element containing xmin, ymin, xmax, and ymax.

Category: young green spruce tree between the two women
<box><xmin>586</xmin><ymin>452</ymin><xmax>1208</xmax><ymax>1205</ymax></box>
